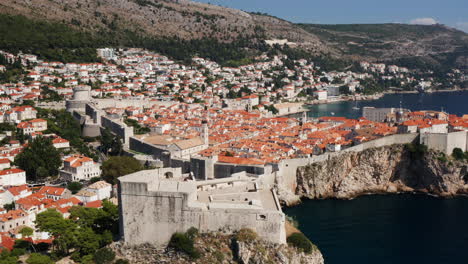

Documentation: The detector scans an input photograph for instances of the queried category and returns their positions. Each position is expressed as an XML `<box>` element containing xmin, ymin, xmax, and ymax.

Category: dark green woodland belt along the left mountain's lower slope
<box><xmin>0</xmin><ymin>14</ymin><xmax>263</xmax><ymax>65</ymax></box>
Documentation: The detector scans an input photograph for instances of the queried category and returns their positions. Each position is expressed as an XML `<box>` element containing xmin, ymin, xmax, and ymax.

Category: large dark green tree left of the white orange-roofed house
<box><xmin>15</xmin><ymin>137</ymin><xmax>62</xmax><ymax>181</ymax></box>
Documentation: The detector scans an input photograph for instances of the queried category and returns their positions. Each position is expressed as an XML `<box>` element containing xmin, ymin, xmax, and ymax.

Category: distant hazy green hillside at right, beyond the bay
<box><xmin>299</xmin><ymin>24</ymin><xmax>468</xmax><ymax>71</ymax></box>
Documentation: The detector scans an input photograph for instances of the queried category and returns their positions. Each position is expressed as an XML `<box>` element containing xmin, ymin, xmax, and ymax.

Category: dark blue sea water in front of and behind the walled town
<box><xmin>285</xmin><ymin>91</ymin><xmax>468</xmax><ymax>264</ymax></box>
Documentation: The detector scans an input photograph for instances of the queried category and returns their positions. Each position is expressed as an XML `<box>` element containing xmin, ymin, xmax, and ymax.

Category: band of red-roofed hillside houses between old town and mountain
<box><xmin>0</xmin><ymin>48</ymin><xmax>464</xmax><ymax>114</ymax></box>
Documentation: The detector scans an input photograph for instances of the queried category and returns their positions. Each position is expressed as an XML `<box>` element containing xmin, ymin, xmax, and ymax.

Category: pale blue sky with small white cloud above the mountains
<box><xmin>196</xmin><ymin>0</ymin><xmax>468</xmax><ymax>32</ymax></box>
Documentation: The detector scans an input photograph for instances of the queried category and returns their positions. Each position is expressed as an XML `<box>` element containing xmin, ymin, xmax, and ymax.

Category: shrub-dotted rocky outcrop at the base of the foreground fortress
<box><xmin>111</xmin><ymin>233</ymin><xmax>324</xmax><ymax>264</ymax></box>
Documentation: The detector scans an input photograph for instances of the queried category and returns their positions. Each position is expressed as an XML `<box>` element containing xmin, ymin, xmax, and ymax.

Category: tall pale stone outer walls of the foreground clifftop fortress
<box><xmin>119</xmin><ymin>171</ymin><xmax>286</xmax><ymax>246</ymax></box>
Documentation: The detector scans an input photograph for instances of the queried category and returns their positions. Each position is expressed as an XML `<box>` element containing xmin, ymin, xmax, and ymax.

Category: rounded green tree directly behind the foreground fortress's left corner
<box><xmin>102</xmin><ymin>156</ymin><xmax>143</xmax><ymax>184</ymax></box>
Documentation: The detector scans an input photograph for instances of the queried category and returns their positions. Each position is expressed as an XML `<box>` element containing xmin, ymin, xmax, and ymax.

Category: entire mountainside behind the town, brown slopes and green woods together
<box><xmin>0</xmin><ymin>0</ymin><xmax>468</xmax><ymax>71</ymax></box>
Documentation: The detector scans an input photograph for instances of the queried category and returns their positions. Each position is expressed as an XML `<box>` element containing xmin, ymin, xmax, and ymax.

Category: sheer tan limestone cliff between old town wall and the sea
<box><xmin>294</xmin><ymin>145</ymin><xmax>468</xmax><ymax>200</ymax></box>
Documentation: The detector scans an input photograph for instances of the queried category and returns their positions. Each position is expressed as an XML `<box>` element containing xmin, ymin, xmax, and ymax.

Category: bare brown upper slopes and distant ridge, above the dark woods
<box><xmin>0</xmin><ymin>0</ymin><xmax>468</xmax><ymax>70</ymax></box>
